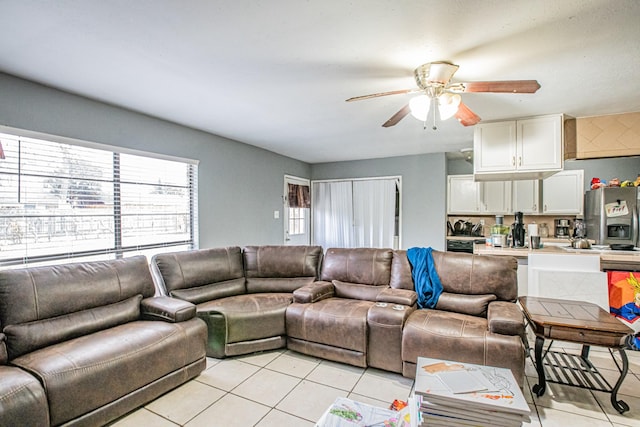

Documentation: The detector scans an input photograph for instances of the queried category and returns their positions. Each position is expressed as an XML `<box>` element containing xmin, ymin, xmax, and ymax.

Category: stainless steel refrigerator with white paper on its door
<box><xmin>584</xmin><ymin>187</ymin><xmax>638</xmax><ymax>246</ymax></box>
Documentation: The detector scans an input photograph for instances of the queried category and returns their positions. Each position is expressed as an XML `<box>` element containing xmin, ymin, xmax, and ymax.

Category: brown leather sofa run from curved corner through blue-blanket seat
<box><xmin>151</xmin><ymin>246</ymin><xmax>525</xmax><ymax>384</ymax></box>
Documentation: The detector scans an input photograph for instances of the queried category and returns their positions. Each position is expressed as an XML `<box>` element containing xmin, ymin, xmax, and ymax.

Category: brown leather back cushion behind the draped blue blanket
<box><xmin>390</xmin><ymin>250</ymin><xmax>518</xmax><ymax>301</ymax></box>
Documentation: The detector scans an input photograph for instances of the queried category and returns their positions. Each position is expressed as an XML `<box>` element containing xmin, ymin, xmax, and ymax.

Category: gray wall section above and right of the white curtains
<box><xmin>311</xmin><ymin>153</ymin><xmax>447</xmax><ymax>250</ymax></box>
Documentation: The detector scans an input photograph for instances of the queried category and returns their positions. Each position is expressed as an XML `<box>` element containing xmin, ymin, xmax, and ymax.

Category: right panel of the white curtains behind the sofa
<box><xmin>353</xmin><ymin>179</ymin><xmax>396</xmax><ymax>248</ymax></box>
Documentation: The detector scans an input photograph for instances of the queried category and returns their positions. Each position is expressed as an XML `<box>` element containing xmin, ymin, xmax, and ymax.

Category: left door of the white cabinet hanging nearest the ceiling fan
<box><xmin>473</xmin><ymin>121</ymin><xmax>516</xmax><ymax>172</ymax></box>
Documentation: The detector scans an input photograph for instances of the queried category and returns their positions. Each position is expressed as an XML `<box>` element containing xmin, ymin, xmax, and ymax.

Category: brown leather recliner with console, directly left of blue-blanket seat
<box><xmin>287</xmin><ymin>248</ymin><xmax>417</xmax><ymax>372</ymax></box>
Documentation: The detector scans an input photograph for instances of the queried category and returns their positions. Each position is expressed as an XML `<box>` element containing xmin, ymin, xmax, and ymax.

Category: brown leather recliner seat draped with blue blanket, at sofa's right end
<box><xmin>398</xmin><ymin>250</ymin><xmax>525</xmax><ymax>386</ymax></box>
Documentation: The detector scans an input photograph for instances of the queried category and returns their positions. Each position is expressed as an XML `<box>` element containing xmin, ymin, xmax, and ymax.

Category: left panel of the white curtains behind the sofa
<box><xmin>311</xmin><ymin>181</ymin><xmax>353</xmax><ymax>249</ymax></box>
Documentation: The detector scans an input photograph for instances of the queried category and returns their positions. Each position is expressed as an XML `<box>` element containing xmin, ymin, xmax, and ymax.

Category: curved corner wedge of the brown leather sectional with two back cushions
<box><xmin>151</xmin><ymin>246</ymin><xmax>322</xmax><ymax>358</ymax></box>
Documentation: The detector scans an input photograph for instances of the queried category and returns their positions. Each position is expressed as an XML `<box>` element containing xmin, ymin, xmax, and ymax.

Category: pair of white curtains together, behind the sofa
<box><xmin>311</xmin><ymin>179</ymin><xmax>396</xmax><ymax>249</ymax></box>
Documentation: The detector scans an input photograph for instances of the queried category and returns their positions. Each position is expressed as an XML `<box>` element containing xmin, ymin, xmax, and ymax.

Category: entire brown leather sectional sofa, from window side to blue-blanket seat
<box><xmin>0</xmin><ymin>246</ymin><xmax>525</xmax><ymax>426</ymax></box>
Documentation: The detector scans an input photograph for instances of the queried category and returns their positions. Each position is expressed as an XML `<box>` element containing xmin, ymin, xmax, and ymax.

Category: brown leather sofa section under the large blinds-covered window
<box><xmin>0</xmin><ymin>256</ymin><xmax>206</xmax><ymax>426</ymax></box>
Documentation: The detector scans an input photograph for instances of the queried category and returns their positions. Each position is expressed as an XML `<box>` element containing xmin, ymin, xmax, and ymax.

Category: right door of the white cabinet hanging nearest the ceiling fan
<box><xmin>516</xmin><ymin>115</ymin><xmax>563</xmax><ymax>170</ymax></box>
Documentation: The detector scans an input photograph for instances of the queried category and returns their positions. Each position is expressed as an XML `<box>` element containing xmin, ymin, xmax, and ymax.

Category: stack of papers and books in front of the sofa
<box><xmin>415</xmin><ymin>357</ymin><xmax>530</xmax><ymax>427</ymax></box>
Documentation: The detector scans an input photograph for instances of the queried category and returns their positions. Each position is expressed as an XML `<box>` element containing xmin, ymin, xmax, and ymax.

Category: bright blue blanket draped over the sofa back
<box><xmin>407</xmin><ymin>248</ymin><xmax>442</xmax><ymax>308</ymax></box>
